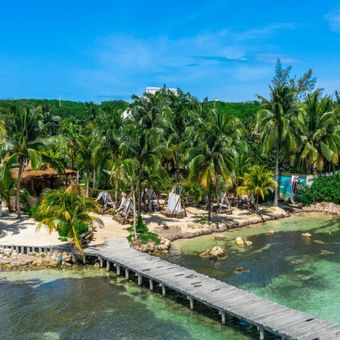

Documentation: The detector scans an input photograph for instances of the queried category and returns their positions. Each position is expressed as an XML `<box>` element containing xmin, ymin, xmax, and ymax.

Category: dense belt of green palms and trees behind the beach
<box><xmin>0</xmin><ymin>62</ymin><xmax>340</xmax><ymax>228</ymax></box>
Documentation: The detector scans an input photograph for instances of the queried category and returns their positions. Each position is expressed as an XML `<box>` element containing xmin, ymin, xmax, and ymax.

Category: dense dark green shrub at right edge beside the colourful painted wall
<box><xmin>296</xmin><ymin>173</ymin><xmax>340</xmax><ymax>205</ymax></box>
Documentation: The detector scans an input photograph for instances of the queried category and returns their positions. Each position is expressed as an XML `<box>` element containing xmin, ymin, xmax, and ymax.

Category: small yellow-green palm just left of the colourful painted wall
<box><xmin>237</xmin><ymin>165</ymin><xmax>277</xmax><ymax>211</ymax></box>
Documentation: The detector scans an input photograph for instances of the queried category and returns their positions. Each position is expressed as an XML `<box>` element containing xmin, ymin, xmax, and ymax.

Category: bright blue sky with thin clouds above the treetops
<box><xmin>0</xmin><ymin>0</ymin><xmax>340</xmax><ymax>102</ymax></box>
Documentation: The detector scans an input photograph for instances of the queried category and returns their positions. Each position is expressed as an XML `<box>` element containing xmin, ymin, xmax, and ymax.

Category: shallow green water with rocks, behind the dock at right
<box><xmin>167</xmin><ymin>213</ymin><xmax>340</xmax><ymax>323</ymax></box>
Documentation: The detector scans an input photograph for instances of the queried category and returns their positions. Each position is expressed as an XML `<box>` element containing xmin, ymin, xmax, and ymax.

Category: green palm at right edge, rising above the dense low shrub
<box><xmin>297</xmin><ymin>91</ymin><xmax>340</xmax><ymax>172</ymax></box>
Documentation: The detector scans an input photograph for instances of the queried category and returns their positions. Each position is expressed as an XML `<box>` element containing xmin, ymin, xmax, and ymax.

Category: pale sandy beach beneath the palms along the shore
<box><xmin>0</xmin><ymin>207</ymin><xmax>289</xmax><ymax>246</ymax></box>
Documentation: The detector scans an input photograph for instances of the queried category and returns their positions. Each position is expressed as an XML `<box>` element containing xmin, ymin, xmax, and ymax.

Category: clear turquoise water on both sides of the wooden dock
<box><xmin>0</xmin><ymin>214</ymin><xmax>340</xmax><ymax>340</ymax></box>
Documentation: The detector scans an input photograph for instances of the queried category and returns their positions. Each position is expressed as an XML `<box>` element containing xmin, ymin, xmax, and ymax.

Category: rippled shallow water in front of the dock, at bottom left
<box><xmin>0</xmin><ymin>269</ymin><xmax>253</xmax><ymax>340</ymax></box>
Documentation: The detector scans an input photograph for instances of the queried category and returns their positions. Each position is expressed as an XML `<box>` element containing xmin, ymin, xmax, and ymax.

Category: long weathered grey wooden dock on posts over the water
<box><xmin>85</xmin><ymin>239</ymin><xmax>340</xmax><ymax>340</ymax></box>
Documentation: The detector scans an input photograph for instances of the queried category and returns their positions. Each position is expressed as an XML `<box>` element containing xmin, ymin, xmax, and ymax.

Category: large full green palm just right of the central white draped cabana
<box><xmin>188</xmin><ymin>101</ymin><xmax>242</xmax><ymax>221</ymax></box>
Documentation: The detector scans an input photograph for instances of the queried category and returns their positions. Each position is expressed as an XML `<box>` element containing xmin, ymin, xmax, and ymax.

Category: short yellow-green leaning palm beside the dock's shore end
<box><xmin>37</xmin><ymin>185</ymin><xmax>98</xmax><ymax>254</ymax></box>
